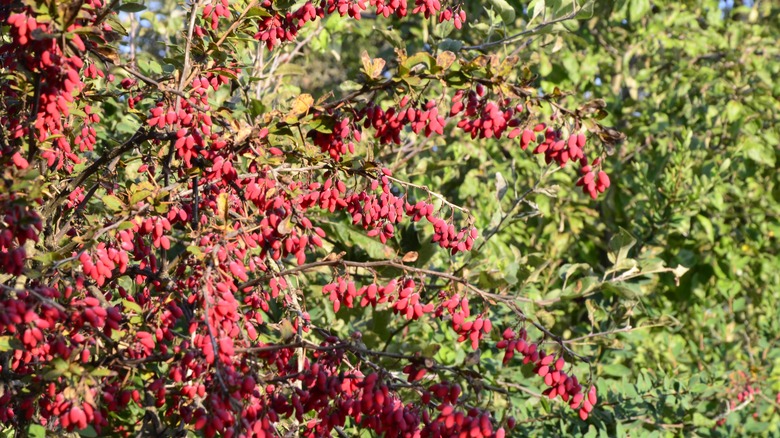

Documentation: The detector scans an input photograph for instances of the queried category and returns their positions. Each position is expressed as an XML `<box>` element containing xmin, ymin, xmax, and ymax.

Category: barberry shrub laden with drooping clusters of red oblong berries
<box><xmin>0</xmin><ymin>0</ymin><xmax>772</xmax><ymax>437</ymax></box>
